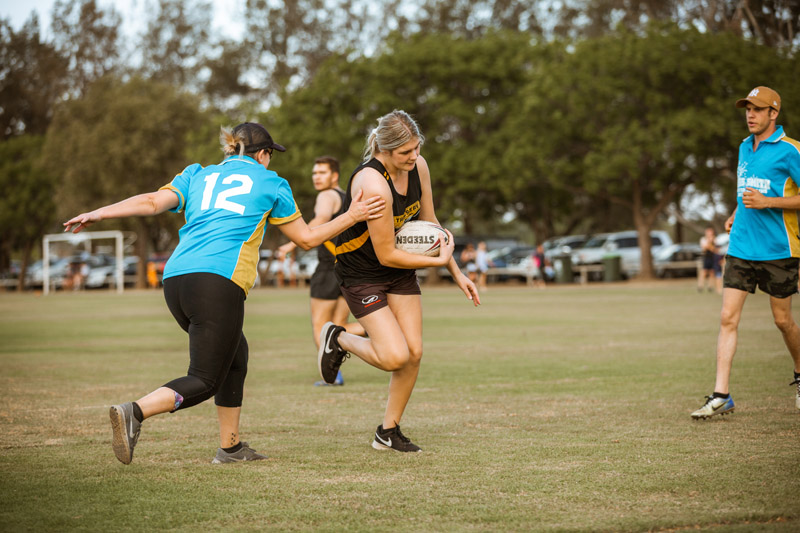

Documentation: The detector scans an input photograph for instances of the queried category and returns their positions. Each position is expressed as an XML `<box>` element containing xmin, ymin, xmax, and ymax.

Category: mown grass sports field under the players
<box><xmin>0</xmin><ymin>281</ymin><xmax>800</xmax><ymax>532</ymax></box>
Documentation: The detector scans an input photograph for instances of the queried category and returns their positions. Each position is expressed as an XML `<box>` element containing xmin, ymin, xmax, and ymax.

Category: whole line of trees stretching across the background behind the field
<box><xmin>0</xmin><ymin>0</ymin><xmax>800</xmax><ymax>286</ymax></box>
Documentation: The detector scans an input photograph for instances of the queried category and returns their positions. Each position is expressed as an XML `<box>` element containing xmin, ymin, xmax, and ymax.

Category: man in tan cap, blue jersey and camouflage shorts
<box><xmin>692</xmin><ymin>87</ymin><xmax>800</xmax><ymax>419</ymax></box>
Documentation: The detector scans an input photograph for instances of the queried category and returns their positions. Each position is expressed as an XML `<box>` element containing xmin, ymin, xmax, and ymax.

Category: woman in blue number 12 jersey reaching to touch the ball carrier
<box><xmin>64</xmin><ymin>122</ymin><xmax>383</xmax><ymax>464</ymax></box>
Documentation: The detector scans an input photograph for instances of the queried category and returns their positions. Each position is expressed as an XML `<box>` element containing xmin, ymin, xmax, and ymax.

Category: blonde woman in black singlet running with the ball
<box><xmin>318</xmin><ymin>111</ymin><xmax>480</xmax><ymax>452</ymax></box>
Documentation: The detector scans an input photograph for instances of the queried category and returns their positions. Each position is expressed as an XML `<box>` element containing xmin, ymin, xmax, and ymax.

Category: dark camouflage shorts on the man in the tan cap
<box><xmin>722</xmin><ymin>255</ymin><xmax>800</xmax><ymax>298</ymax></box>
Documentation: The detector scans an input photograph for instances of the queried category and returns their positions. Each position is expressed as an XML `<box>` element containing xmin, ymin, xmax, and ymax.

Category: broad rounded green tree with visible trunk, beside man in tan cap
<box><xmin>506</xmin><ymin>25</ymin><xmax>798</xmax><ymax>277</ymax></box>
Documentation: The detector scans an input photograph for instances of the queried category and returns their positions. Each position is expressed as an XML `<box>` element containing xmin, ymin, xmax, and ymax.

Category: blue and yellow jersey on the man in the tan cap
<box><xmin>728</xmin><ymin>126</ymin><xmax>800</xmax><ymax>261</ymax></box>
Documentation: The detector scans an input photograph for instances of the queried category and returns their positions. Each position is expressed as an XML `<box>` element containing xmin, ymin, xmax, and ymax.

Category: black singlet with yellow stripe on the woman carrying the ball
<box><xmin>334</xmin><ymin>158</ymin><xmax>422</xmax><ymax>286</ymax></box>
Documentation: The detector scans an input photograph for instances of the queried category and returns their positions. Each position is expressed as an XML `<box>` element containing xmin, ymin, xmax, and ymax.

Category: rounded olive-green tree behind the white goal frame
<box><xmin>45</xmin><ymin>77</ymin><xmax>209</xmax><ymax>286</ymax></box>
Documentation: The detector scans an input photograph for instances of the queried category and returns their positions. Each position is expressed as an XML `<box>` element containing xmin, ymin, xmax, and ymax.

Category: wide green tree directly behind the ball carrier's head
<box><xmin>267</xmin><ymin>32</ymin><xmax>537</xmax><ymax>232</ymax></box>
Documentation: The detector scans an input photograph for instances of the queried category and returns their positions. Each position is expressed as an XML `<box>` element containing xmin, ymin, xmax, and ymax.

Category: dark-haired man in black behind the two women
<box><xmin>278</xmin><ymin>156</ymin><xmax>364</xmax><ymax>385</ymax></box>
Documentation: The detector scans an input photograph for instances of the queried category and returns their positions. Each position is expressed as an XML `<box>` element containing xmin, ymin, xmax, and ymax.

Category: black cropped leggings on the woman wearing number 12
<box><xmin>164</xmin><ymin>273</ymin><xmax>248</xmax><ymax>409</ymax></box>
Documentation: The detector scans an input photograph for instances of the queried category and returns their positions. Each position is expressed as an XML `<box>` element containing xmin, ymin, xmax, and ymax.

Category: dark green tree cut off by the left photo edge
<box><xmin>0</xmin><ymin>134</ymin><xmax>56</xmax><ymax>290</ymax></box>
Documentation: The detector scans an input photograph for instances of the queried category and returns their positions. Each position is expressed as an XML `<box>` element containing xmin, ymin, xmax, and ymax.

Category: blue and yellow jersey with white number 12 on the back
<box><xmin>161</xmin><ymin>156</ymin><xmax>301</xmax><ymax>293</ymax></box>
